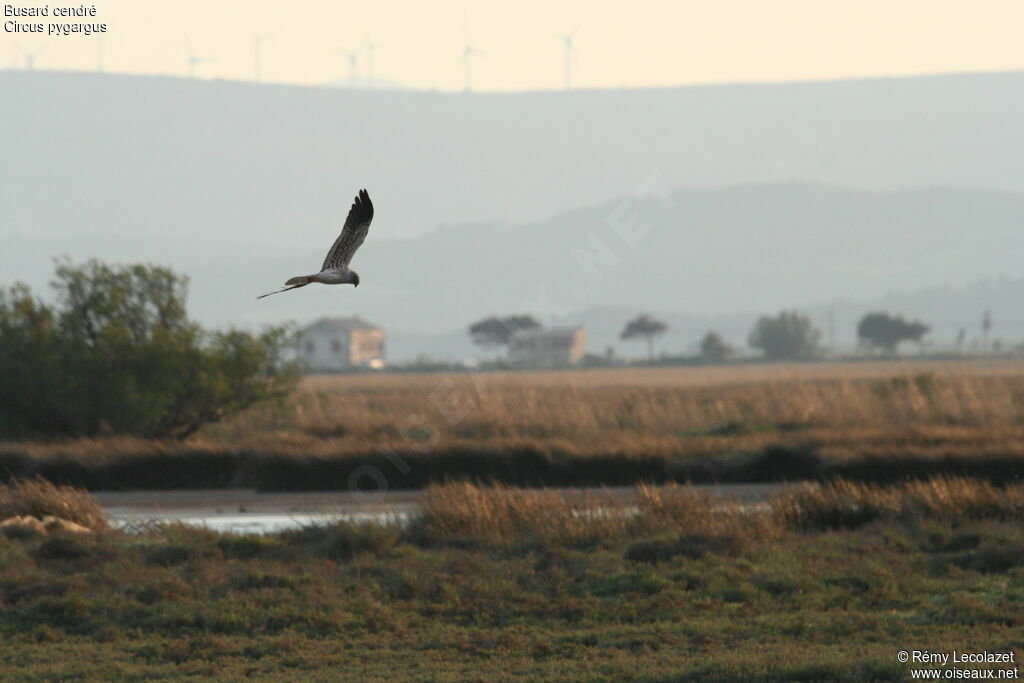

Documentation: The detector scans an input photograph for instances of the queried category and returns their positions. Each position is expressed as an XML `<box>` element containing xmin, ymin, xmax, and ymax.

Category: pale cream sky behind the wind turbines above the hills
<box><xmin>0</xmin><ymin>0</ymin><xmax>1024</xmax><ymax>91</ymax></box>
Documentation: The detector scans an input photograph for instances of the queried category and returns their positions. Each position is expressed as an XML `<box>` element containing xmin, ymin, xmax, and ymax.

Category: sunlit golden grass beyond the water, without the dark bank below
<box><xmin>207</xmin><ymin>362</ymin><xmax>1024</xmax><ymax>444</ymax></box>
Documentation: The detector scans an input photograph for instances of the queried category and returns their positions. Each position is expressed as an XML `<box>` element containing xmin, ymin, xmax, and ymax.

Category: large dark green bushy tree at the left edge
<box><xmin>0</xmin><ymin>261</ymin><xmax>297</xmax><ymax>438</ymax></box>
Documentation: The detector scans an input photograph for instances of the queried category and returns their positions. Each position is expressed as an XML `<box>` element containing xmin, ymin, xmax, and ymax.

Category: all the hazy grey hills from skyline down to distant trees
<box><xmin>6</xmin><ymin>72</ymin><xmax>1024</xmax><ymax>357</ymax></box>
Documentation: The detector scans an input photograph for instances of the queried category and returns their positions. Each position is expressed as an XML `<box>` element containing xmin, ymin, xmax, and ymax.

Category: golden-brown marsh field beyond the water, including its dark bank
<box><xmin>0</xmin><ymin>361</ymin><xmax>1024</xmax><ymax>490</ymax></box>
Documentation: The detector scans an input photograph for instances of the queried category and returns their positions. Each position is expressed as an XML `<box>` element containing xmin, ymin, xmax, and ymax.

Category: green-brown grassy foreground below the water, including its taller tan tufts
<box><xmin>0</xmin><ymin>479</ymin><xmax>1024</xmax><ymax>681</ymax></box>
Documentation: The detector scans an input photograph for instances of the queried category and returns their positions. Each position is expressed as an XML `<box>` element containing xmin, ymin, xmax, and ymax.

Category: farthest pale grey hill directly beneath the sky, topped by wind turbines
<box><xmin>6</xmin><ymin>71</ymin><xmax>1024</xmax><ymax>245</ymax></box>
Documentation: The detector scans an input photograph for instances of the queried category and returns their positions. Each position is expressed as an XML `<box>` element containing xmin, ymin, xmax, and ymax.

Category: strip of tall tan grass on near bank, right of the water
<box><xmin>416</xmin><ymin>477</ymin><xmax>1024</xmax><ymax>552</ymax></box>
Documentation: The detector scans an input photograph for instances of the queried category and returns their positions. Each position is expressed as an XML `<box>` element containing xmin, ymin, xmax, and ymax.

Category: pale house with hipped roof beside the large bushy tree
<box><xmin>299</xmin><ymin>317</ymin><xmax>384</xmax><ymax>372</ymax></box>
